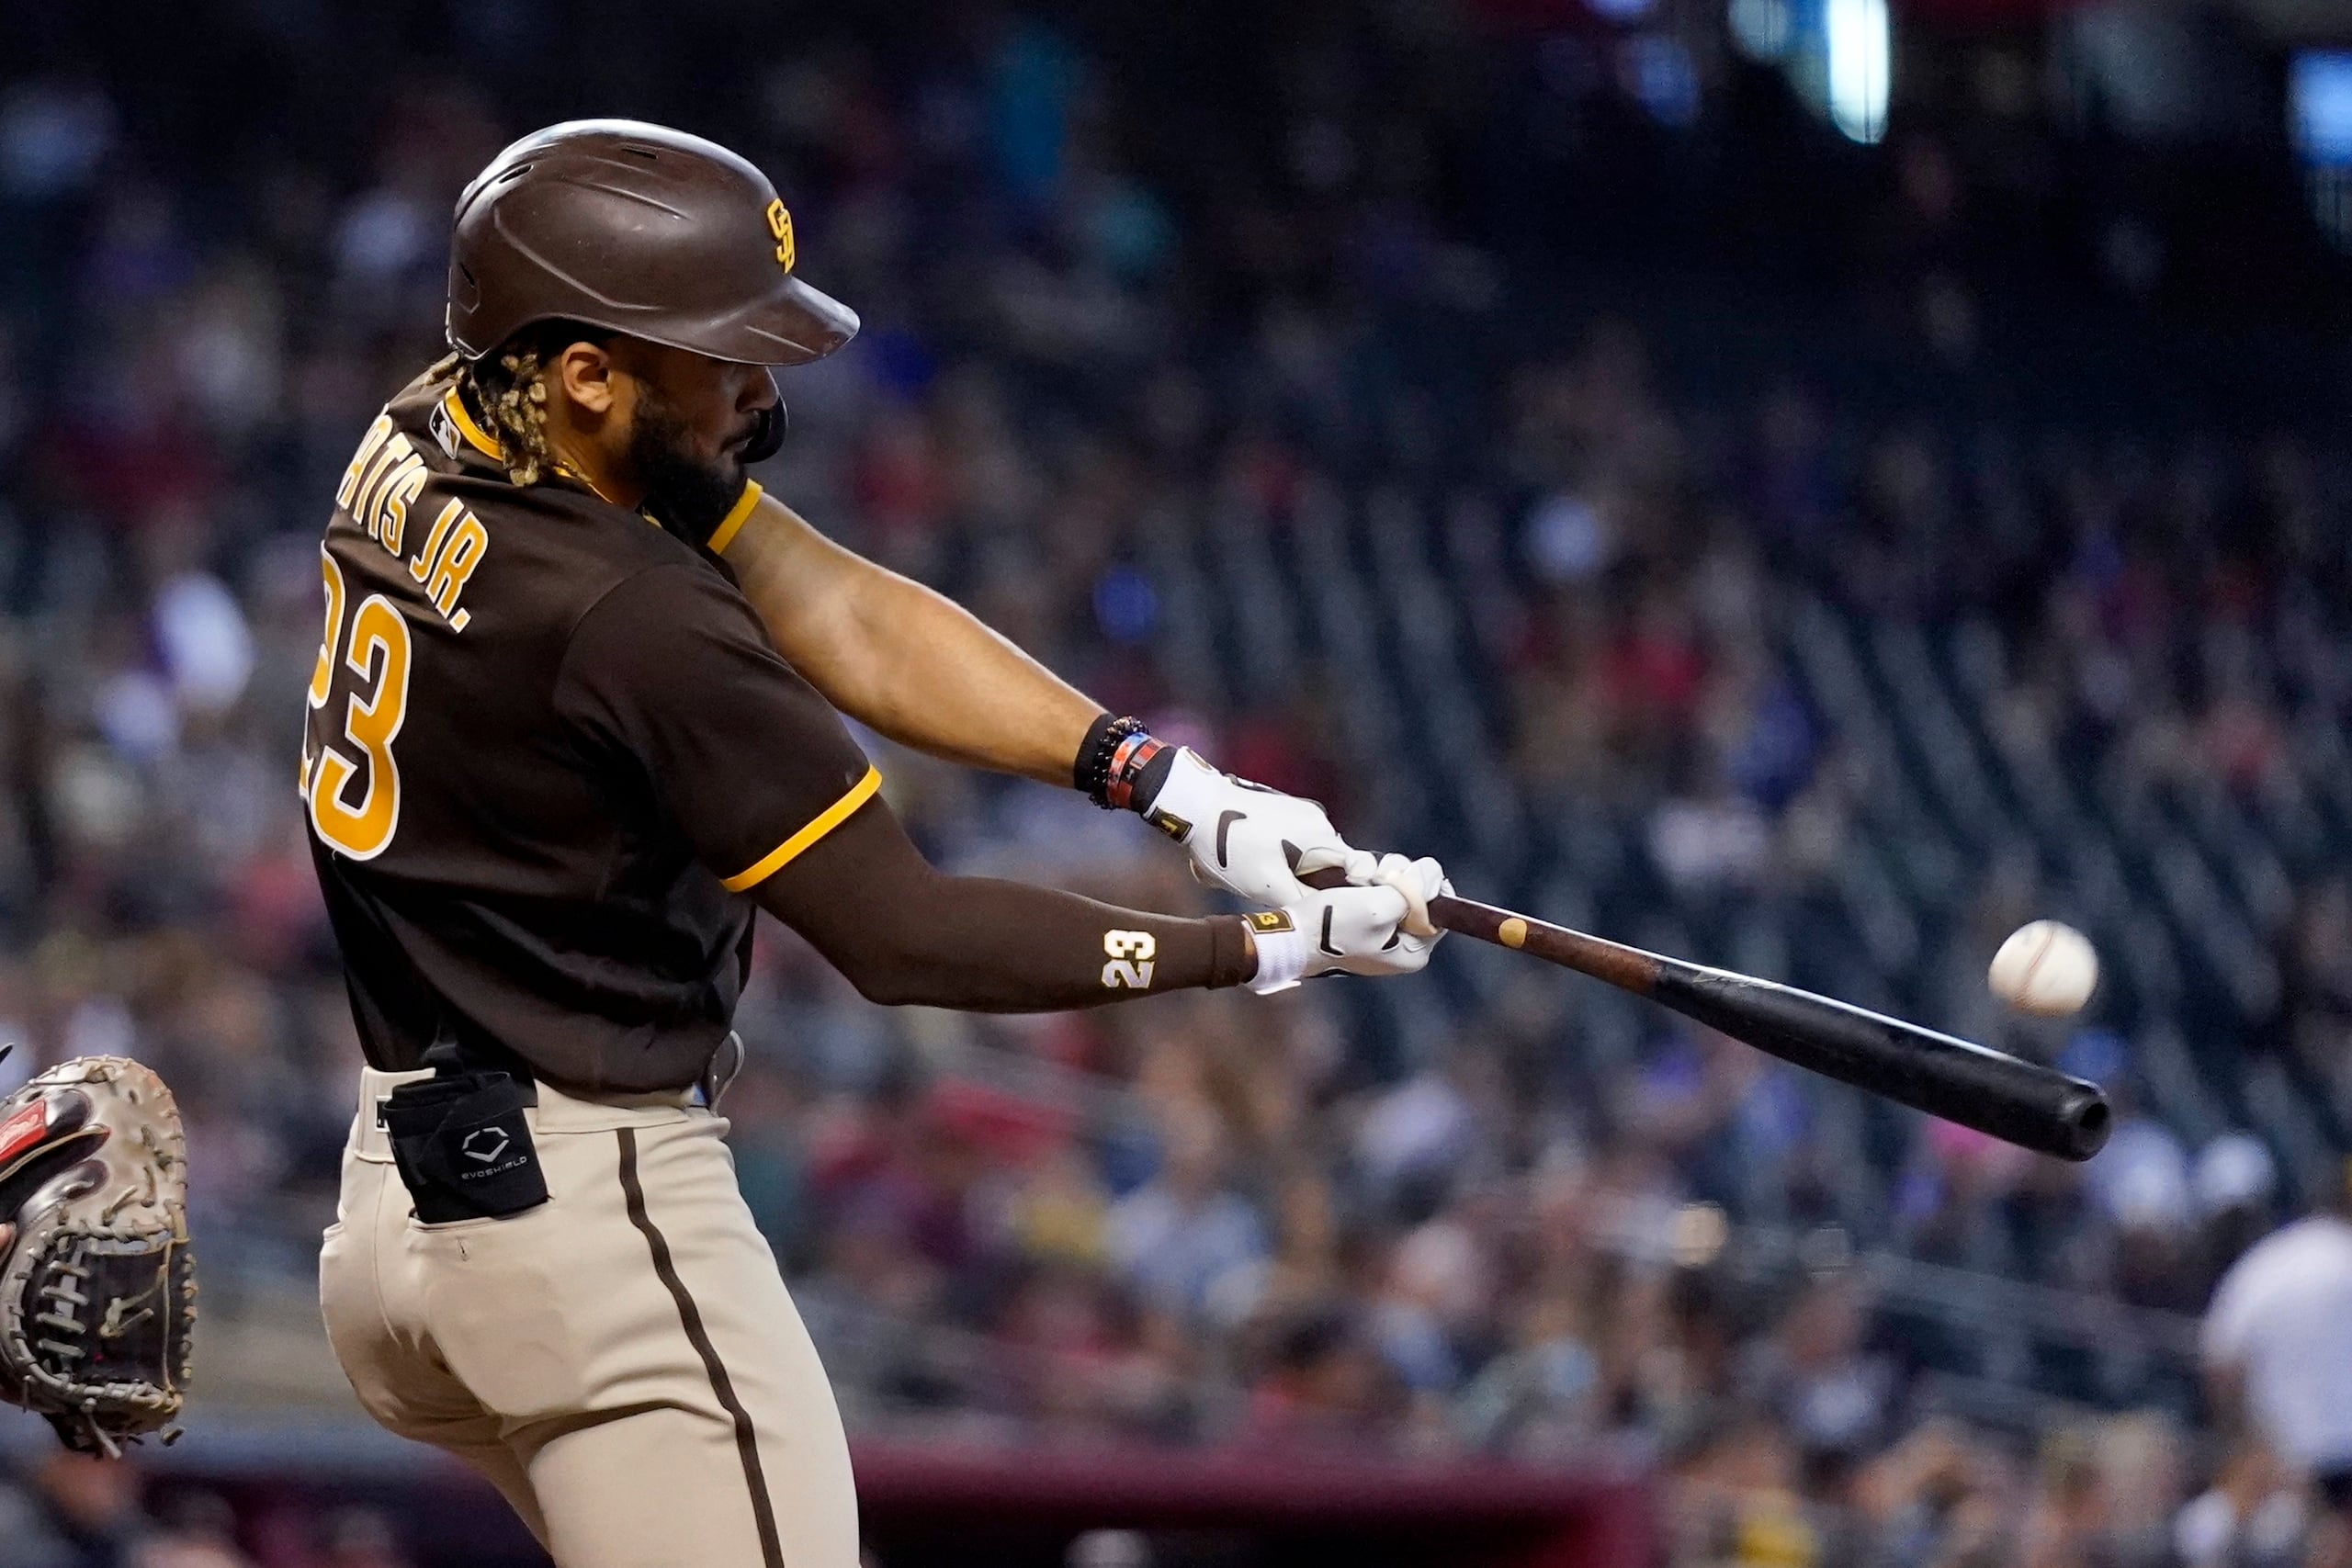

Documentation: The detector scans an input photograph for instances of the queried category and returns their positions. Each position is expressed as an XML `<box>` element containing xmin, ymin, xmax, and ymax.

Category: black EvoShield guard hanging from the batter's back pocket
<box><xmin>383</xmin><ymin>1072</ymin><xmax>548</xmax><ymax>1224</ymax></box>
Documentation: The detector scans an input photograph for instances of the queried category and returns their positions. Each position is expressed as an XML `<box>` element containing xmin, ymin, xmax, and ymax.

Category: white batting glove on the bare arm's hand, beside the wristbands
<box><xmin>1141</xmin><ymin>748</ymin><xmax>1374</xmax><ymax>909</ymax></box>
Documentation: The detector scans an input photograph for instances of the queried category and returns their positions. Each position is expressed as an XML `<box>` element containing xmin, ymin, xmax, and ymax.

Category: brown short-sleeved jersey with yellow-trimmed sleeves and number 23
<box><xmin>301</xmin><ymin>378</ymin><xmax>879</xmax><ymax>1090</ymax></box>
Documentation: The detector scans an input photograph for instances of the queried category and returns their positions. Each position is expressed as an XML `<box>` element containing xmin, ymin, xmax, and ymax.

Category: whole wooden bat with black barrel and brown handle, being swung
<box><xmin>1306</xmin><ymin>872</ymin><xmax>2112</xmax><ymax>1159</ymax></box>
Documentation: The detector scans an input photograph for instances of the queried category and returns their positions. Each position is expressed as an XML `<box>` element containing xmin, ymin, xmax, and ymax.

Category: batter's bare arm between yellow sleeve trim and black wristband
<box><xmin>724</xmin><ymin>496</ymin><xmax>1101</xmax><ymax>785</ymax></box>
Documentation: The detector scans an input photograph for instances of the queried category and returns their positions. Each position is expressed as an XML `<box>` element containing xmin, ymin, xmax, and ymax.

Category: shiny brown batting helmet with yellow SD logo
<box><xmin>449</xmin><ymin>120</ymin><xmax>858</xmax><ymax>365</ymax></box>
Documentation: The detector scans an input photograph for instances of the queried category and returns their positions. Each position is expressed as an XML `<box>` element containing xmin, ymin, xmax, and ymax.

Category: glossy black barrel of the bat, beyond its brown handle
<box><xmin>1649</xmin><ymin>959</ymin><xmax>2112</xmax><ymax>1159</ymax></box>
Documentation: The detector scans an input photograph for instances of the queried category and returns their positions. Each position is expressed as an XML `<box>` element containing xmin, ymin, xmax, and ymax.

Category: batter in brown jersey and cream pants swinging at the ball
<box><xmin>301</xmin><ymin>120</ymin><xmax>1442</xmax><ymax>1568</ymax></box>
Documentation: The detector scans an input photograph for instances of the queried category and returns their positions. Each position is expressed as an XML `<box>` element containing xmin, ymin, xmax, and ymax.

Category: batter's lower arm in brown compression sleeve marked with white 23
<box><xmin>757</xmin><ymin>802</ymin><xmax>1256</xmax><ymax>1013</ymax></box>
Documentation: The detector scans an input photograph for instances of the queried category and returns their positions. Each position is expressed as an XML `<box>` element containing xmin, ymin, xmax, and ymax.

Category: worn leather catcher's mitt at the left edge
<box><xmin>0</xmin><ymin>1048</ymin><xmax>195</xmax><ymax>1455</ymax></box>
